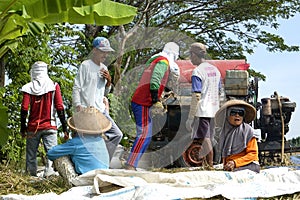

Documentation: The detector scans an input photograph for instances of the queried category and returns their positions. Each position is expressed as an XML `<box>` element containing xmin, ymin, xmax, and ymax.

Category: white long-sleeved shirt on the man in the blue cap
<box><xmin>72</xmin><ymin>59</ymin><xmax>110</xmax><ymax>113</ymax></box>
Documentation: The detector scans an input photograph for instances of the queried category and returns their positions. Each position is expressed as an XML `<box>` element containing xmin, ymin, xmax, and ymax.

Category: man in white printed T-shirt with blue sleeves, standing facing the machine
<box><xmin>186</xmin><ymin>43</ymin><xmax>221</xmax><ymax>167</ymax></box>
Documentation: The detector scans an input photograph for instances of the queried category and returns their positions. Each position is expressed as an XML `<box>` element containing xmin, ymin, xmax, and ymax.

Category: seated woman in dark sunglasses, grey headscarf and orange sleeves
<box><xmin>215</xmin><ymin>100</ymin><xmax>260</xmax><ymax>173</ymax></box>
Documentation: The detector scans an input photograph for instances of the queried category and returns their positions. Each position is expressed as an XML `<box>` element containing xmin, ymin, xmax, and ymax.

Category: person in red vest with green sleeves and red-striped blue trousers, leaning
<box><xmin>125</xmin><ymin>42</ymin><xmax>179</xmax><ymax>170</ymax></box>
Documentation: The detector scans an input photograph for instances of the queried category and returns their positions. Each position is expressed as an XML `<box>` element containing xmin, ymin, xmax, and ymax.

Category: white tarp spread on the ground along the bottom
<box><xmin>2</xmin><ymin>167</ymin><xmax>300</xmax><ymax>200</ymax></box>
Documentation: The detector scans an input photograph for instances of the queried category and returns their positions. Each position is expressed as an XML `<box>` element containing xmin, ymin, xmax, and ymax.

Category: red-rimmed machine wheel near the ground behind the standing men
<box><xmin>177</xmin><ymin>141</ymin><xmax>205</xmax><ymax>167</ymax></box>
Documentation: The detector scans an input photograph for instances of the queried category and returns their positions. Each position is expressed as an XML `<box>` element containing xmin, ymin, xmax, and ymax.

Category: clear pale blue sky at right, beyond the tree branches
<box><xmin>247</xmin><ymin>15</ymin><xmax>300</xmax><ymax>139</ymax></box>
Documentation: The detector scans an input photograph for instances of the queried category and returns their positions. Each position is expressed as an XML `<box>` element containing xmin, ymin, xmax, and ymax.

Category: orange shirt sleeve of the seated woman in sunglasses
<box><xmin>224</xmin><ymin>137</ymin><xmax>258</xmax><ymax>168</ymax></box>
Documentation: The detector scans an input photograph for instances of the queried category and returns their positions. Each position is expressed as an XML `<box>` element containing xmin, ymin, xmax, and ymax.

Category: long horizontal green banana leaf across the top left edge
<box><xmin>0</xmin><ymin>0</ymin><xmax>137</xmax><ymax>26</ymax></box>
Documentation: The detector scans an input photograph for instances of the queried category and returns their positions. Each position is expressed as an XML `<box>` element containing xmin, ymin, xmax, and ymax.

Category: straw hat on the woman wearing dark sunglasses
<box><xmin>215</xmin><ymin>99</ymin><xmax>256</xmax><ymax>127</ymax></box>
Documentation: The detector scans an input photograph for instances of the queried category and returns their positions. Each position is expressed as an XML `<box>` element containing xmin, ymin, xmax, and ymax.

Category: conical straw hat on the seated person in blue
<box><xmin>67</xmin><ymin>107</ymin><xmax>112</xmax><ymax>134</ymax></box>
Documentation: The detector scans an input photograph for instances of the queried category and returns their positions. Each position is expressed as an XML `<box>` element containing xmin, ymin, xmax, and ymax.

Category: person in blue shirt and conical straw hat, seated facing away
<box><xmin>47</xmin><ymin>107</ymin><xmax>112</xmax><ymax>183</ymax></box>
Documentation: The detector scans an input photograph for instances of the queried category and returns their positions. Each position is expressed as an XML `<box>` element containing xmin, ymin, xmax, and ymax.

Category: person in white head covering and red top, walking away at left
<box><xmin>20</xmin><ymin>61</ymin><xmax>68</xmax><ymax>176</ymax></box>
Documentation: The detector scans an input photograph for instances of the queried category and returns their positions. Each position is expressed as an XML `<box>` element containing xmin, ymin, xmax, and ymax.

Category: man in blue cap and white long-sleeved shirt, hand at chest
<box><xmin>72</xmin><ymin>37</ymin><xmax>123</xmax><ymax>160</ymax></box>
